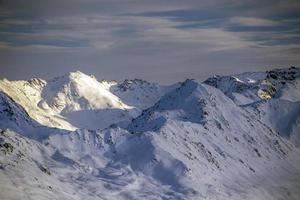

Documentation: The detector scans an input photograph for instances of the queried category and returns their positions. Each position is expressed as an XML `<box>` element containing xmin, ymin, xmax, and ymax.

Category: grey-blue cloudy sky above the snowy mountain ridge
<box><xmin>0</xmin><ymin>0</ymin><xmax>300</xmax><ymax>84</ymax></box>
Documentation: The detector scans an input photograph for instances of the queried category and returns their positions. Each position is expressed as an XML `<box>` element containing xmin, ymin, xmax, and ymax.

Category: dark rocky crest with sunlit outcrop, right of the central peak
<box><xmin>204</xmin><ymin>67</ymin><xmax>300</xmax><ymax>105</ymax></box>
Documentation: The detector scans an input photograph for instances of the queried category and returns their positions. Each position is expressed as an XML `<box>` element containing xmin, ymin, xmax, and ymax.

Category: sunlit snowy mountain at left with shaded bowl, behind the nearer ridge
<box><xmin>0</xmin><ymin>71</ymin><xmax>172</xmax><ymax>130</ymax></box>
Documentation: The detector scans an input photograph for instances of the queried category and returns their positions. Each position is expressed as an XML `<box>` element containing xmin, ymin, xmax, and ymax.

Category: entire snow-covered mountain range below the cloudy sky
<box><xmin>0</xmin><ymin>68</ymin><xmax>300</xmax><ymax>200</ymax></box>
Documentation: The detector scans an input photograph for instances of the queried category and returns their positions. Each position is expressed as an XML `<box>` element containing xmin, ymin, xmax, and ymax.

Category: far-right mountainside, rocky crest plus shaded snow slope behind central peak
<box><xmin>204</xmin><ymin>67</ymin><xmax>300</xmax><ymax>146</ymax></box>
